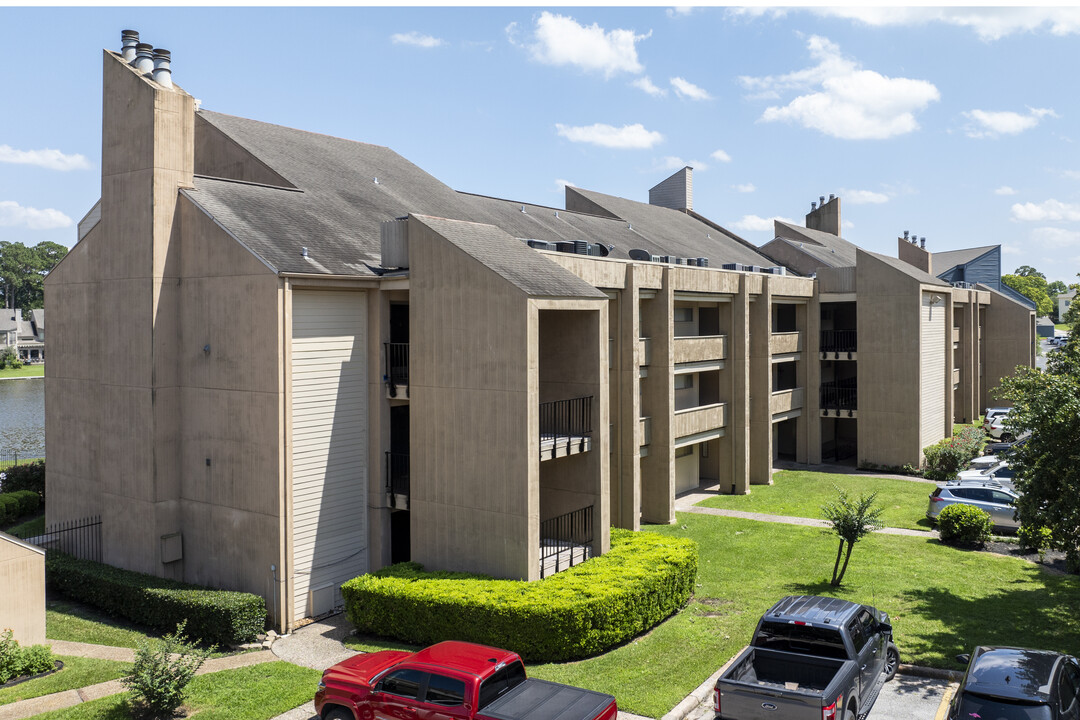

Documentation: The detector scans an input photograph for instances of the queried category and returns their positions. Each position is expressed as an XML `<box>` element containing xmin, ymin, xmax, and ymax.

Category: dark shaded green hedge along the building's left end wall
<box><xmin>45</xmin><ymin>551</ymin><xmax>267</xmax><ymax>646</ymax></box>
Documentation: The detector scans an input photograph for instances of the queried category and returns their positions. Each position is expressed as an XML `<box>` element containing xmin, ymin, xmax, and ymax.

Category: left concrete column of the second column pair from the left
<box><xmin>726</xmin><ymin>275</ymin><xmax>751</xmax><ymax>495</ymax></box>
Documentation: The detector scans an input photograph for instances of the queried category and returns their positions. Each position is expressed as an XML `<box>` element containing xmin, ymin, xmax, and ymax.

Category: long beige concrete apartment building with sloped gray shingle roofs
<box><xmin>45</xmin><ymin>32</ymin><xmax>1034</xmax><ymax>628</ymax></box>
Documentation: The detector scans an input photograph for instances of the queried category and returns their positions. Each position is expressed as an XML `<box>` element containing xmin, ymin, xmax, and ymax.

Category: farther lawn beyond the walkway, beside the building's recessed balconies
<box><xmin>698</xmin><ymin>471</ymin><xmax>934</xmax><ymax>530</ymax></box>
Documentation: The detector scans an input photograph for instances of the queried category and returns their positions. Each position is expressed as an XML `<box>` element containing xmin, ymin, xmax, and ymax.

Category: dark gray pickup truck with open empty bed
<box><xmin>713</xmin><ymin>596</ymin><xmax>900</xmax><ymax>720</ymax></box>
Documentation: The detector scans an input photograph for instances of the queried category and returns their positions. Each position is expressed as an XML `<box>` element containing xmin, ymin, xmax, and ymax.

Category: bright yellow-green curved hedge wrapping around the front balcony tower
<box><xmin>341</xmin><ymin>529</ymin><xmax>698</xmax><ymax>662</ymax></box>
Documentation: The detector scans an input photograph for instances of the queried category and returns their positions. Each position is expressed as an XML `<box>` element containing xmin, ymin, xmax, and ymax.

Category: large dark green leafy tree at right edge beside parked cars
<box><xmin>997</xmin><ymin>334</ymin><xmax>1080</xmax><ymax>570</ymax></box>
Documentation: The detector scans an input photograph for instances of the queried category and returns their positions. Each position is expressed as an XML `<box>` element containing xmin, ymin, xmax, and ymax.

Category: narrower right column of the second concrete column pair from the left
<box><xmin>750</xmin><ymin>275</ymin><xmax>772</xmax><ymax>485</ymax></box>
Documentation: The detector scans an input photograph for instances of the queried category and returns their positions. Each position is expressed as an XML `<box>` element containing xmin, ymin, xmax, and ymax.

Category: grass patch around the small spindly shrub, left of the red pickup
<box><xmin>24</xmin><ymin>661</ymin><xmax>322</xmax><ymax>720</ymax></box>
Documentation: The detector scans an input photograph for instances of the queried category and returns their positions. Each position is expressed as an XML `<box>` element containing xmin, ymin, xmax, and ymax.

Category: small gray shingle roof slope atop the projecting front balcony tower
<box><xmin>414</xmin><ymin>215</ymin><xmax>607</xmax><ymax>299</ymax></box>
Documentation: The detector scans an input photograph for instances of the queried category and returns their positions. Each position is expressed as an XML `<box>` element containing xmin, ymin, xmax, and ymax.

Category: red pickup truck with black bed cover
<box><xmin>315</xmin><ymin>641</ymin><xmax>619</xmax><ymax>720</ymax></box>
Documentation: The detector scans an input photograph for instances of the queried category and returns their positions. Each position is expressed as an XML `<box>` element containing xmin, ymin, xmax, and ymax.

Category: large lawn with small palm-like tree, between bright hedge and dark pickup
<box><xmin>341</xmin><ymin>515</ymin><xmax>1080</xmax><ymax>718</ymax></box>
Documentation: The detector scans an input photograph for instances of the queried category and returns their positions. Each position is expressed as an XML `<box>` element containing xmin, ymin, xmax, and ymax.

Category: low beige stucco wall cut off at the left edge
<box><xmin>0</xmin><ymin>532</ymin><xmax>45</xmax><ymax>647</ymax></box>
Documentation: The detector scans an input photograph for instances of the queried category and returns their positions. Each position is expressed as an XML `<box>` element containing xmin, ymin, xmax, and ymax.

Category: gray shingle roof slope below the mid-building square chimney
<box><xmin>567</xmin><ymin>188</ymin><xmax>774</xmax><ymax>267</ymax></box>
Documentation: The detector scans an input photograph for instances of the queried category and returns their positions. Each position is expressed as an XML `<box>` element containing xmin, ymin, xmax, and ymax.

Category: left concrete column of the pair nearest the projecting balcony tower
<box><xmin>611</xmin><ymin>264</ymin><xmax>645</xmax><ymax>530</ymax></box>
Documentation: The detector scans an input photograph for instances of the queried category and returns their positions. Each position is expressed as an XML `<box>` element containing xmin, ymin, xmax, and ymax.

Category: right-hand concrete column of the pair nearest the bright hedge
<box><xmin>642</xmin><ymin>268</ymin><xmax>675</xmax><ymax>525</ymax></box>
